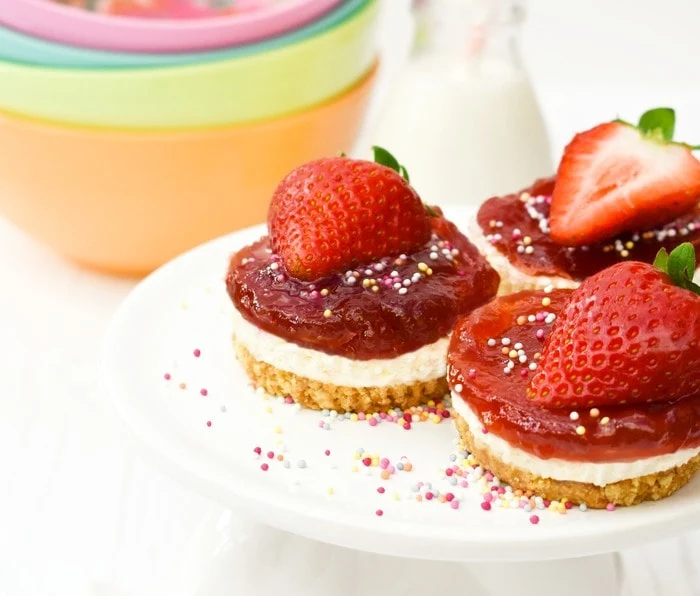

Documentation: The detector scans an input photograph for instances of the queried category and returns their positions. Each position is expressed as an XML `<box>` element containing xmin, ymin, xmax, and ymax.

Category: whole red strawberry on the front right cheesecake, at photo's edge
<box><xmin>528</xmin><ymin>243</ymin><xmax>700</xmax><ymax>408</ymax></box>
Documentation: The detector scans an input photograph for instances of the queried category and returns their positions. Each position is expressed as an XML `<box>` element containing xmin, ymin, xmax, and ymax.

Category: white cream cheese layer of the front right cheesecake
<box><xmin>452</xmin><ymin>392</ymin><xmax>700</xmax><ymax>486</ymax></box>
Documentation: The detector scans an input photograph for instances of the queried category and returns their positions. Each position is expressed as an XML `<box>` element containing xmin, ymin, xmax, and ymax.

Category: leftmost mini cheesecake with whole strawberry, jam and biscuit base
<box><xmin>226</xmin><ymin>148</ymin><xmax>499</xmax><ymax>412</ymax></box>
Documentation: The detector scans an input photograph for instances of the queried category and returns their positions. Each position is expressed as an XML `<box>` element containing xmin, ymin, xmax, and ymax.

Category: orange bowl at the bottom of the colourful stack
<box><xmin>0</xmin><ymin>64</ymin><xmax>377</xmax><ymax>275</ymax></box>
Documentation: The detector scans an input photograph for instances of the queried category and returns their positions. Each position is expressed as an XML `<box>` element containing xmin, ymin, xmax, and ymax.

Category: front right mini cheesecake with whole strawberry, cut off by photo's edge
<box><xmin>448</xmin><ymin>244</ymin><xmax>700</xmax><ymax>508</ymax></box>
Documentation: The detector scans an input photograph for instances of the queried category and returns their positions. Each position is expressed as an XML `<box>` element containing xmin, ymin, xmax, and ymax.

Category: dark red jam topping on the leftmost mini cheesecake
<box><xmin>226</xmin><ymin>217</ymin><xmax>500</xmax><ymax>360</ymax></box>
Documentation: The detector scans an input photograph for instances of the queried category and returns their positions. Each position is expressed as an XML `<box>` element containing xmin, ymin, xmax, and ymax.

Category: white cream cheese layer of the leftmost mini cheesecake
<box><xmin>233</xmin><ymin>310</ymin><xmax>449</xmax><ymax>387</ymax></box>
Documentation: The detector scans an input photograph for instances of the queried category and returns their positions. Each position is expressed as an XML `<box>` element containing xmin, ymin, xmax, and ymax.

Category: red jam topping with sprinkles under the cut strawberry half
<box><xmin>477</xmin><ymin>178</ymin><xmax>700</xmax><ymax>281</ymax></box>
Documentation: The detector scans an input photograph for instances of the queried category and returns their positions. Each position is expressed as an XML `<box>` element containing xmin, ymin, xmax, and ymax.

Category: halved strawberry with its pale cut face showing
<box><xmin>550</xmin><ymin>108</ymin><xmax>700</xmax><ymax>246</ymax></box>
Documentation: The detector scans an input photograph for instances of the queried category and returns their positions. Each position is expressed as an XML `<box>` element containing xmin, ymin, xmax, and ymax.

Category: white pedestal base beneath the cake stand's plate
<box><xmin>180</xmin><ymin>510</ymin><xmax>622</xmax><ymax>596</ymax></box>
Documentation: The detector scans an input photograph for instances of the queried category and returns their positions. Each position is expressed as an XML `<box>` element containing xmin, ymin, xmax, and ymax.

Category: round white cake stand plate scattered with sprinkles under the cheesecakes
<box><xmin>102</xmin><ymin>210</ymin><xmax>700</xmax><ymax>561</ymax></box>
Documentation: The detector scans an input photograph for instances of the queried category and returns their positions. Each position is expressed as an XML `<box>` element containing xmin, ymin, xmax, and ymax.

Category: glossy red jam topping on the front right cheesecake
<box><xmin>448</xmin><ymin>290</ymin><xmax>700</xmax><ymax>462</ymax></box>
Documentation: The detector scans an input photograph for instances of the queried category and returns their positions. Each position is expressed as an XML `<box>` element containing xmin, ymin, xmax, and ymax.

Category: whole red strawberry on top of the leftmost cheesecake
<box><xmin>268</xmin><ymin>147</ymin><xmax>431</xmax><ymax>280</ymax></box>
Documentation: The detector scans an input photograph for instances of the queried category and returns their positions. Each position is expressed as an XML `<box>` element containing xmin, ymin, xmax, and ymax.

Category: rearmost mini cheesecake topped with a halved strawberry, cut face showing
<box><xmin>468</xmin><ymin>108</ymin><xmax>700</xmax><ymax>294</ymax></box>
